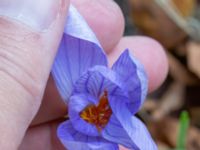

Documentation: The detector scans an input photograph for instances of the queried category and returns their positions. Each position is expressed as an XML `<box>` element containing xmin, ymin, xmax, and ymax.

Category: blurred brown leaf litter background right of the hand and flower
<box><xmin>116</xmin><ymin>0</ymin><xmax>200</xmax><ymax>150</ymax></box>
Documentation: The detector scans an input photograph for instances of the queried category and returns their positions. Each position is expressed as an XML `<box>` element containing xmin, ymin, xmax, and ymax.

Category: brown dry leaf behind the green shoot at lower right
<box><xmin>149</xmin><ymin>116</ymin><xmax>200</xmax><ymax>150</ymax></box>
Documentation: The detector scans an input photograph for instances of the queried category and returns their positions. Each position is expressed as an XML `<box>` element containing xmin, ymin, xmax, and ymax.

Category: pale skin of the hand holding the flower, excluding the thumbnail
<box><xmin>0</xmin><ymin>0</ymin><xmax>168</xmax><ymax>150</ymax></box>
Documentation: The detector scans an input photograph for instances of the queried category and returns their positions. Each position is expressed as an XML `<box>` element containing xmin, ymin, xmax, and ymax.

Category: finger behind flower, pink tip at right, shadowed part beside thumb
<box><xmin>33</xmin><ymin>37</ymin><xmax>168</xmax><ymax>124</ymax></box>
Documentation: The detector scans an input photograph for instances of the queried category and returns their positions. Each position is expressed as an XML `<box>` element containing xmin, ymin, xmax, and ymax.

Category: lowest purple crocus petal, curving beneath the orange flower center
<box><xmin>57</xmin><ymin>121</ymin><xmax>119</xmax><ymax>150</ymax></box>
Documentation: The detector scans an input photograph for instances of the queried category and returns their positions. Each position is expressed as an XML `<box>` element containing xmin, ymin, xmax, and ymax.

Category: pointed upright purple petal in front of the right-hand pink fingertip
<box><xmin>112</xmin><ymin>50</ymin><xmax>148</xmax><ymax>113</ymax></box>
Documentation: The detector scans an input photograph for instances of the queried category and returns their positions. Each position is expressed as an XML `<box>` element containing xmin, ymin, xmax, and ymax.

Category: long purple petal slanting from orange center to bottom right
<box><xmin>109</xmin><ymin>96</ymin><xmax>157</xmax><ymax>150</ymax></box>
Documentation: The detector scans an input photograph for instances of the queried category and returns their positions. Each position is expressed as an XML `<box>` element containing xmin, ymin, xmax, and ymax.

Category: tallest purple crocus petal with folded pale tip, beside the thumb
<box><xmin>52</xmin><ymin>5</ymin><xmax>107</xmax><ymax>102</ymax></box>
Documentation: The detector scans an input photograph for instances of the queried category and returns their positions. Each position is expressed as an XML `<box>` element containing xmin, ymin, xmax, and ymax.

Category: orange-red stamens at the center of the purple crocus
<box><xmin>80</xmin><ymin>91</ymin><xmax>112</xmax><ymax>131</ymax></box>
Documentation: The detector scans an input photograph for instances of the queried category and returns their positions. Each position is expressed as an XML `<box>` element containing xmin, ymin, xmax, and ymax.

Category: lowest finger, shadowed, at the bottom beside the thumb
<box><xmin>19</xmin><ymin>122</ymin><xmax>127</xmax><ymax>150</ymax></box>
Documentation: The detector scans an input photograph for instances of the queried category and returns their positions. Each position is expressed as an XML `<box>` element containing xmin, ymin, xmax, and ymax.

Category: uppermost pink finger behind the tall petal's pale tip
<box><xmin>71</xmin><ymin>0</ymin><xmax>124</xmax><ymax>52</ymax></box>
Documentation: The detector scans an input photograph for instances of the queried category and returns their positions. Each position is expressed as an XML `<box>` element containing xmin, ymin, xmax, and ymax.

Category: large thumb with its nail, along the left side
<box><xmin>0</xmin><ymin>0</ymin><xmax>69</xmax><ymax>150</ymax></box>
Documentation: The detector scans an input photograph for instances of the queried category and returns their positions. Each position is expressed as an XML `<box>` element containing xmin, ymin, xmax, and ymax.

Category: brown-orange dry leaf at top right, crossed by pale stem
<box><xmin>129</xmin><ymin>0</ymin><xmax>196</xmax><ymax>48</ymax></box>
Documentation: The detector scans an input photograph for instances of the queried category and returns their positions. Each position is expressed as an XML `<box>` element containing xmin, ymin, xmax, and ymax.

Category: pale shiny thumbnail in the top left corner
<box><xmin>0</xmin><ymin>0</ymin><xmax>65</xmax><ymax>30</ymax></box>
